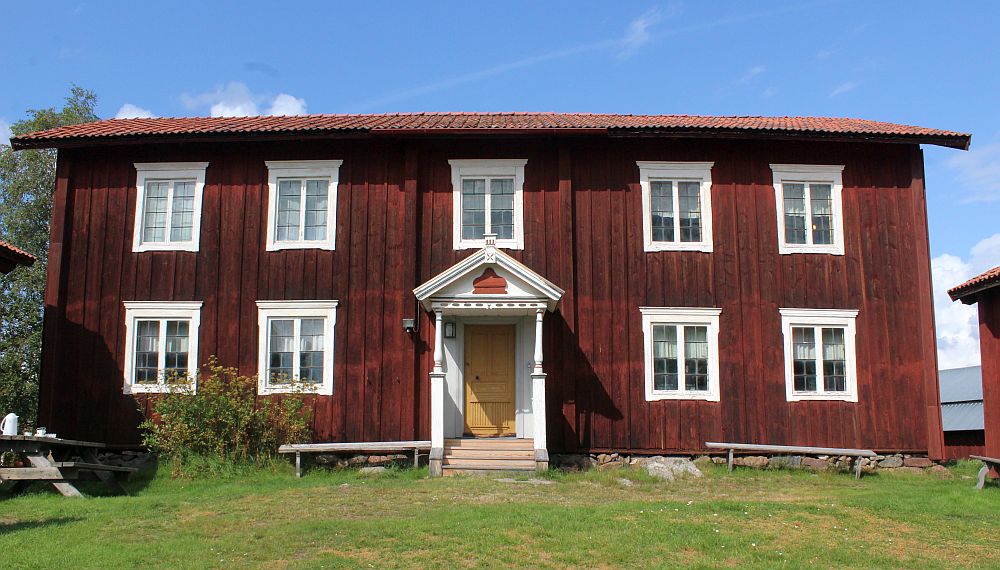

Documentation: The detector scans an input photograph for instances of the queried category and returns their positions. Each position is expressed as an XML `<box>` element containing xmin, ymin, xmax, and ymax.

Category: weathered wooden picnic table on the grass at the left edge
<box><xmin>0</xmin><ymin>435</ymin><xmax>136</xmax><ymax>497</ymax></box>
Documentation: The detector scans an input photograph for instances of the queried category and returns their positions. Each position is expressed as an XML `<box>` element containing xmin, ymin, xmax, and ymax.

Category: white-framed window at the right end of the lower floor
<box><xmin>780</xmin><ymin>309</ymin><xmax>858</xmax><ymax>402</ymax></box>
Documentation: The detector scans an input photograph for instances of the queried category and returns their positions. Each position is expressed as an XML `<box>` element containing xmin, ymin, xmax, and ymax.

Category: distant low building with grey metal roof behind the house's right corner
<box><xmin>938</xmin><ymin>366</ymin><xmax>986</xmax><ymax>459</ymax></box>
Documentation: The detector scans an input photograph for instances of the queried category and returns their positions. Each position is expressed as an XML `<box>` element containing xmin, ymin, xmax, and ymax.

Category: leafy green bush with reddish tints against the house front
<box><xmin>140</xmin><ymin>358</ymin><xmax>310</xmax><ymax>476</ymax></box>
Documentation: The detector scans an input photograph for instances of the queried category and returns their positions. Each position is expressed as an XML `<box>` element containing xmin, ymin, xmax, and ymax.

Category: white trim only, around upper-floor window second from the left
<box><xmin>264</xmin><ymin>160</ymin><xmax>344</xmax><ymax>251</ymax></box>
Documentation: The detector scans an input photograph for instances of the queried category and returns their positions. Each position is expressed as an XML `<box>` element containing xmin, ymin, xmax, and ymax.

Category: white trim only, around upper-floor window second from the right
<box><xmin>636</xmin><ymin>161</ymin><xmax>715</xmax><ymax>253</ymax></box>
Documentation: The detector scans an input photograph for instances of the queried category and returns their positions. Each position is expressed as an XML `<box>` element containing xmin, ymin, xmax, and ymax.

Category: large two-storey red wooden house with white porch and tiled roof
<box><xmin>12</xmin><ymin>113</ymin><xmax>970</xmax><ymax>472</ymax></box>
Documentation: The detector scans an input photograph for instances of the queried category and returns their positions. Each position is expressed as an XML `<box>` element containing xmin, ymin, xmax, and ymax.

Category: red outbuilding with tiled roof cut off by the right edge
<box><xmin>948</xmin><ymin>266</ymin><xmax>1000</xmax><ymax>457</ymax></box>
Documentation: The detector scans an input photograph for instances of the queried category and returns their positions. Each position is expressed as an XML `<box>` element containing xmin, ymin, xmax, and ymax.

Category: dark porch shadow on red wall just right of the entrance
<box><xmin>545</xmin><ymin>311</ymin><xmax>625</xmax><ymax>451</ymax></box>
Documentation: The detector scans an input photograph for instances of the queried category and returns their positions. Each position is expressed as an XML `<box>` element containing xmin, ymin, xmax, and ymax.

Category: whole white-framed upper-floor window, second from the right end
<box><xmin>636</xmin><ymin>161</ymin><xmax>714</xmax><ymax>252</ymax></box>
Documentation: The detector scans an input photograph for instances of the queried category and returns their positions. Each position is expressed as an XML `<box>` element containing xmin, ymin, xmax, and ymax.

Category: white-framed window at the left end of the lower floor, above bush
<box><xmin>123</xmin><ymin>301</ymin><xmax>201</xmax><ymax>394</ymax></box>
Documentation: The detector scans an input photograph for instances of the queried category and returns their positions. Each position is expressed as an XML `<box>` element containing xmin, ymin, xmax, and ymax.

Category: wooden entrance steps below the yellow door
<box><xmin>441</xmin><ymin>438</ymin><xmax>535</xmax><ymax>476</ymax></box>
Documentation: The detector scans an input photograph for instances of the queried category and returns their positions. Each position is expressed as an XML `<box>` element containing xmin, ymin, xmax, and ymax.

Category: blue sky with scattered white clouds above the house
<box><xmin>0</xmin><ymin>0</ymin><xmax>1000</xmax><ymax>366</ymax></box>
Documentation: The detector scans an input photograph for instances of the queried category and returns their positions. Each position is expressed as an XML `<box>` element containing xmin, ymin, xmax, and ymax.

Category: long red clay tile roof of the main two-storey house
<box><xmin>11</xmin><ymin>113</ymin><xmax>972</xmax><ymax>149</ymax></box>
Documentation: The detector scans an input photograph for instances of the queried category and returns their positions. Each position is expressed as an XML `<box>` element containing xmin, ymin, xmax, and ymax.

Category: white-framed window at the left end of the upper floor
<box><xmin>132</xmin><ymin>162</ymin><xmax>208</xmax><ymax>252</ymax></box>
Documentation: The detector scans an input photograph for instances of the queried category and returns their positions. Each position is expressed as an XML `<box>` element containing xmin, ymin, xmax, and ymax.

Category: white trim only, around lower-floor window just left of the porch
<box><xmin>257</xmin><ymin>301</ymin><xmax>338</xmax><ymax>396</ymax></box>
